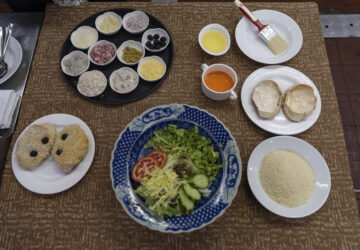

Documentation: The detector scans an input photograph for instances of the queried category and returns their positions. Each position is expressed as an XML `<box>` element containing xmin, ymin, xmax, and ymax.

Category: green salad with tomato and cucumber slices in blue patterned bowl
<box><xmin>132</xmin><ymin>124</ymin><xmax>223</xmax><ymax>218</ymax></box>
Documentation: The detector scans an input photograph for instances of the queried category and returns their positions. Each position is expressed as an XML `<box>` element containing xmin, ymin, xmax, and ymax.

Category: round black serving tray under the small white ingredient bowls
<box><xmin>59</xmin><ymin>8</ymin><xmax>174</xmax><ymax>105</ymax></box>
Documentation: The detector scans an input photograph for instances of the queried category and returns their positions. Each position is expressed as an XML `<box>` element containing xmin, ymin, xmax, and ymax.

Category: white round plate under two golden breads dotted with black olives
<box><xmin>11</xmin><ymin>114</ymin><xmax>95</xmax><ymax>194</ymax></box>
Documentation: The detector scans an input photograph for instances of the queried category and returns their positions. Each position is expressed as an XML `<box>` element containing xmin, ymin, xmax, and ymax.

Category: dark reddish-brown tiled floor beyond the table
<box><xmin>0</xmin><ymin>0</ymin><xmax>360</xmax><ymax>213</ymax></box>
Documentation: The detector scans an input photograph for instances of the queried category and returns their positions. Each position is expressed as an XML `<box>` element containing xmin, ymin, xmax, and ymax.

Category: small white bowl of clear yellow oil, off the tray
<box><xmin>198</xmin><ymin>23</ymin><xmax>231</xmax><ymax>56</ymax></box>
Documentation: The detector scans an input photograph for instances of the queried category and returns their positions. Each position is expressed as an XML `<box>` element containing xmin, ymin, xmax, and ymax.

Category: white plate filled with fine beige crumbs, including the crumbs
<box><xmin>247</xmin><ymin>136</ymin><xmax>331</xmax><ymax>218</ymax></box>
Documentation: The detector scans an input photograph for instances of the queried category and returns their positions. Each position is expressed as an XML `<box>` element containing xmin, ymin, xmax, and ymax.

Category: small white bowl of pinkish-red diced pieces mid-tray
<box><xmin>88</xmin><ymin>40</ymin><xmax>116</xmax><ymax>66</ymax></box>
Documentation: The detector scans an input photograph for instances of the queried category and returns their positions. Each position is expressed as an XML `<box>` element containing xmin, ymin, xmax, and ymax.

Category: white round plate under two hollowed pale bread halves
<box><xmin>241</xmin><ymin>65</ymin><xmax>321</xmax><ymax>135</ymax></box>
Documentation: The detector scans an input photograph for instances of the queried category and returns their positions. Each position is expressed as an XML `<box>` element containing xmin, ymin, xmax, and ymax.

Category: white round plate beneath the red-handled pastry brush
<box><xmin>235</xmin><ymin>10</ymin><xmax>303</xmax><ymax>64</ymax></box>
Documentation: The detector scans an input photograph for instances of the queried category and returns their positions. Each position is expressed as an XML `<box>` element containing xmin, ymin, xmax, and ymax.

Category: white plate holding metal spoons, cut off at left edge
<box><xmin>0</xmin><ymin>36</ymin><xmax>22</xmax><ymax>84</ymax></box>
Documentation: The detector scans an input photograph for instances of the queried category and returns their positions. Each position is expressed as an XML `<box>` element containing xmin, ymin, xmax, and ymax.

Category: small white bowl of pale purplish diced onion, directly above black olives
<box><xmin>123</xmin><ymin>10</ymin><xmax>150</xmax><ymax>34</ymax></box>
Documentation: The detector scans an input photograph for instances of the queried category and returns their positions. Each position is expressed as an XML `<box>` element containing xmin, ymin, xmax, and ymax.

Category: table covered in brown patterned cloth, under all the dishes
<box><xmin>0</xmin><ymin>3</ymin><xmax>360</xmax><ymax>249</ymax></box>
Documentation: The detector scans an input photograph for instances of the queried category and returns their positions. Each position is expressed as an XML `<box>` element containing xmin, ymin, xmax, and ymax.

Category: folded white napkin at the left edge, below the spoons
<box><xmin>0</xmin><ymin>90</ymin><xmax>20</xmax><ymax>129</ymax></box>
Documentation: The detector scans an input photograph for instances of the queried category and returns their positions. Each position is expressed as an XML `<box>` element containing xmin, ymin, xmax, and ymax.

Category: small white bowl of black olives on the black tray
<box><xmin>141</xmin><ymin>28</ymin><xmax>170</xmax><ymax>52</ymax></box>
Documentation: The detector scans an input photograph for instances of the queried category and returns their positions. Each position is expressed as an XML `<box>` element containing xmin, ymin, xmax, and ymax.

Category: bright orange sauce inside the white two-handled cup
<box><xmin>204</xmin><ymin>71</ymin><xmax>234</xmax><ymax>92</ymax></box>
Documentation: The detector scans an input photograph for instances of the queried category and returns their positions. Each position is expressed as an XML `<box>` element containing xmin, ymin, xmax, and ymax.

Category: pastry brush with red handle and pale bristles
<box><xmin>235</xmin><ymin>0</ymin><xmax>288</xmax><ymax>55</ymax></box>
